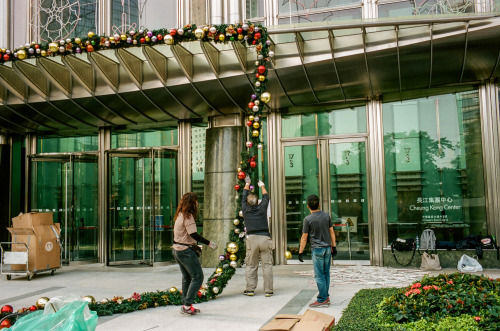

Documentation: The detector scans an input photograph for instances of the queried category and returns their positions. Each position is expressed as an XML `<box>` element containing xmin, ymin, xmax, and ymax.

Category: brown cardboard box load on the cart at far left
<box><xmin>7</xmin><ymin>213</ymin><xmax>61</xmax><ymax>271</ymax></box>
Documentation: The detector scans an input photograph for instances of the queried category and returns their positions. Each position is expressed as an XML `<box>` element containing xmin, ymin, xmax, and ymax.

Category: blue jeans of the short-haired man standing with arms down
<box><xmin>312</xmin><ymin>247</ymin><xmax>332</xmax><ymax>302</ymax></box>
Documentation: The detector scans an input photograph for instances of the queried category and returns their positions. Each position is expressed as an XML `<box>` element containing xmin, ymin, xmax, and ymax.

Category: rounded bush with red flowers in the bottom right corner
<box><xmin>378</xmin><ymin>272</ymin><xmax>500</xmax><ymax>330</ymax></box>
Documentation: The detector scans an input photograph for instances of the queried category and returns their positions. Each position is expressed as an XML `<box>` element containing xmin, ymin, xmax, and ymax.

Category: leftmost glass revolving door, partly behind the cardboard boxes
<box><xmin>29</xmin><ymin>154</ymin><xmax>98</xmax><ymax>263</ymax></box>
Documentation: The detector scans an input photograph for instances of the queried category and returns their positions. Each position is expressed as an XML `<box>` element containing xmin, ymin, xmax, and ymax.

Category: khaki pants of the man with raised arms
<box><xmin>245</xmin><ymin>235</ymin><xmax>274</xmax><ymax>293</ymax></box>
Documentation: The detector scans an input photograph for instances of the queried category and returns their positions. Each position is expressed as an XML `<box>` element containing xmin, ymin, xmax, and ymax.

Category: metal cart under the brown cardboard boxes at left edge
<box><xmin>0</xmin><ymin>242</ymin><xmax>56</xmax><ymax>280</ymax></box>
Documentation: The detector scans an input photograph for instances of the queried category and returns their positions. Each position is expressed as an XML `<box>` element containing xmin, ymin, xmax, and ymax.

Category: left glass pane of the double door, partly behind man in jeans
<box><xmin>284</xmin><ymin>145</ymin><xmax>319</xmax><ymax>258</ymax></box>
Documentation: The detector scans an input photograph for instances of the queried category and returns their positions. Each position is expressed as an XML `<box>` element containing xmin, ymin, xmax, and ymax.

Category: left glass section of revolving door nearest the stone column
<box><xmin>108</xmin><ymin>149</ymin><xmax>154</xmax><ymax>264</ymax></box>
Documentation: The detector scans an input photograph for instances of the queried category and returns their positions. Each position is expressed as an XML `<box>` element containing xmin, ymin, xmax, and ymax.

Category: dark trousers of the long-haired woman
<box><xmin>173</xmin><ymin>248</ymin><xmax>203</xmax><ymax>306</ymax></box>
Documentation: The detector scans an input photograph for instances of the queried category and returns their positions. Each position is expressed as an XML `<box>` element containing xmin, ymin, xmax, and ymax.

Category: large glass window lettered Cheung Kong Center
<box><xmin>383</xmin><ymin>91</ymin><xmax>487</xmax><ymax>242</ymax></box>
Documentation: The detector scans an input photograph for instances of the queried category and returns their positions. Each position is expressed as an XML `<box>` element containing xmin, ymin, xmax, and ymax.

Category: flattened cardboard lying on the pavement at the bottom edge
<box><xmin>260</xmin><ymin>309</ymin><xmax>335</xmax><ymax>331</ymax></box>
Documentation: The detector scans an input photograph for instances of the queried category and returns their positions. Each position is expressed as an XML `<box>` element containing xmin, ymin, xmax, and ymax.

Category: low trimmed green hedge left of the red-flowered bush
<box><xmin>333</xmin><ymin>288</ymin><xmax>399</xmax><ymax>331</ymax></box>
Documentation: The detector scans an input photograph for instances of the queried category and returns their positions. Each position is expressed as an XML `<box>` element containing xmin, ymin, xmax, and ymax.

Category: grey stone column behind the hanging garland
<box><xmin>201</xmin><ymin>114</ymin><xmax>244</xmax><ymax>268</ymax></box>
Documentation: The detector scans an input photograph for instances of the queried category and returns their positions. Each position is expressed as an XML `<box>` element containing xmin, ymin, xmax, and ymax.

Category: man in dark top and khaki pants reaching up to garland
<box><xmin>241</xmin><ymin>176</ymin><xmax>274</xmax><ymax>297</ymax></box>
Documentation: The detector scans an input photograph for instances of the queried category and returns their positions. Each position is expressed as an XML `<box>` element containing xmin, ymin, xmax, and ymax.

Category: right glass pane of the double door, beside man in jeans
<box><xmin>329</xmin><ymin>142</ymin><xmax>370</xmax><ymax>260</ymax></box>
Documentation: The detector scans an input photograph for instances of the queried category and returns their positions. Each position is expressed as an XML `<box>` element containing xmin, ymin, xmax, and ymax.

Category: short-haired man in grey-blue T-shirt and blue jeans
<box><xmin>299</xmin><ymin>195</ymin><xmax>337</xmax><ymax>308</ymax></box>
